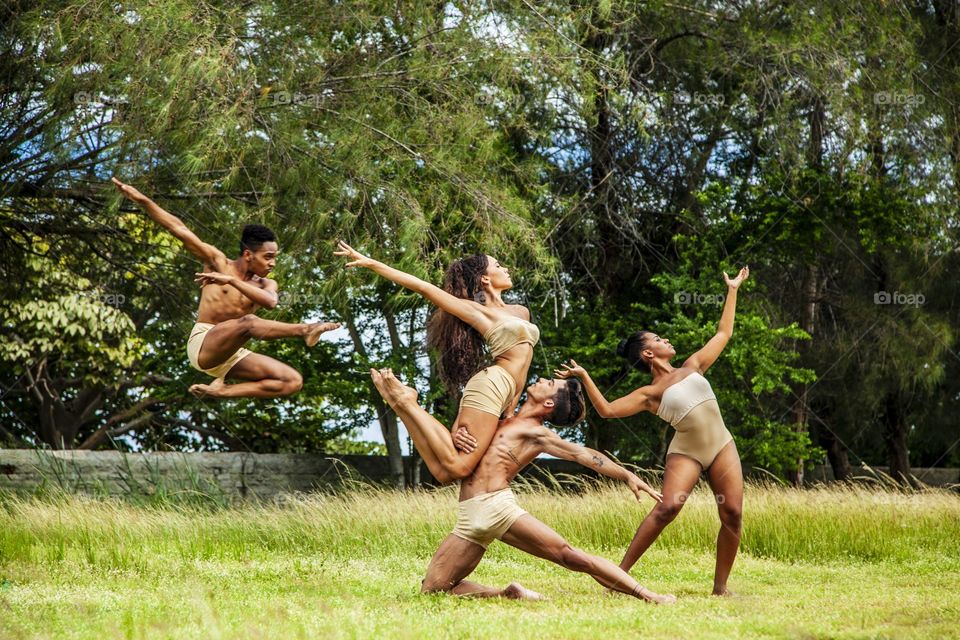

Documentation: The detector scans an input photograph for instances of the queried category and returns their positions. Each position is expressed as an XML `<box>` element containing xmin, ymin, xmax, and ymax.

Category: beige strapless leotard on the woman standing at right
<box><xmin>657</xmin><ymin>372</ymin><xmax>733</xmax><ymax>469</ymax></box>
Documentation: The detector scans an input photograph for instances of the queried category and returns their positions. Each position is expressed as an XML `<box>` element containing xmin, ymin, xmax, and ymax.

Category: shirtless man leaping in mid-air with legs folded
<box><xmin>112</xmin><ymin>178</ymin><xmax>340</xmax><ymax>398</ymax></box>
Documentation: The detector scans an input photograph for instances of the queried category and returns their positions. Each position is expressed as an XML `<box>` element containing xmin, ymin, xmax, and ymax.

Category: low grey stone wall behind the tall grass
<box><xmin>0</xmin><ymin>449</ymin><xmax>960</xmax><ymax>501</ymax></box>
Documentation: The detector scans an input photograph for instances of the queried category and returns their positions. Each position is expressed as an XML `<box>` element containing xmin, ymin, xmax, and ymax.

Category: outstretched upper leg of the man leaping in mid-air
<box><xmin>197</xmin><ymin>313</ymin><xmax>340</xmax><ymax>369</ymax></box>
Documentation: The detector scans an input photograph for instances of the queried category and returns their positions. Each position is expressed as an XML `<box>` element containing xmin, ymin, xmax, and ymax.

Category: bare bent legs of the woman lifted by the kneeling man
<box><xmin>370</xmin><ymin>369</ymin><xmax>500</xmax><ymax>484</ymax></box>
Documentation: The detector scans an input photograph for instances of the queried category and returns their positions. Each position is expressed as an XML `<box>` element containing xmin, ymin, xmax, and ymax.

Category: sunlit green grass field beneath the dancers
<box><xmin>0</xmin><ymin>486</ymin><xmax>960</xmax><ymax>640</ymax></box>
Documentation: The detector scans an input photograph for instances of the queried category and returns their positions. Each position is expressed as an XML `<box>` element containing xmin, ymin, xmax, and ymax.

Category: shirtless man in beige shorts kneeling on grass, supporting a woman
<box><xmin>370</xmin><ymin>369</ymin><xmax>676</xmax><ymax>604</ymax></box>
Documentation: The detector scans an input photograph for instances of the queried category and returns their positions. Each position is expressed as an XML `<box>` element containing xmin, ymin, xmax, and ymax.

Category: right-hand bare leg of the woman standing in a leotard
<box><xmin>707</xmin><ymin>441</ymin><xmax>743</xmax><ymax>596</ymax></box>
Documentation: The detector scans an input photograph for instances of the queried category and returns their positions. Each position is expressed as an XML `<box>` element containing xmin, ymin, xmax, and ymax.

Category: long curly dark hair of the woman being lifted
<box><xmin>427</xmin><ymin>253</ymin><xmax>490</xmax><ymax>396</ymax></box>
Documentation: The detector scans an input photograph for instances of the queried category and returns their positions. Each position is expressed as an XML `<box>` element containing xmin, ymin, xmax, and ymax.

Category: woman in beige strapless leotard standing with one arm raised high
<box><xmin>557</xmin><ymin>267</ymin><xmax>750</xmax><ymax>595</ymax></box>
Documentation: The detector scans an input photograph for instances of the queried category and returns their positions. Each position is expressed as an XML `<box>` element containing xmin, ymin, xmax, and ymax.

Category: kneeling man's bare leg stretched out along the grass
<box><xmin>501</xmin><ymin>513</ymin><xmax>677</xmax><ymax>604</ymax></box>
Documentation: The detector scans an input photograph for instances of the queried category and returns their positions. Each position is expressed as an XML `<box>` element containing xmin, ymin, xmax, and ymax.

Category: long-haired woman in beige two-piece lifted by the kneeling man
<box><xmin>335</xmin><ymin>242</ymin><xmax>579</xmax><ymax>483</ymax></box>
